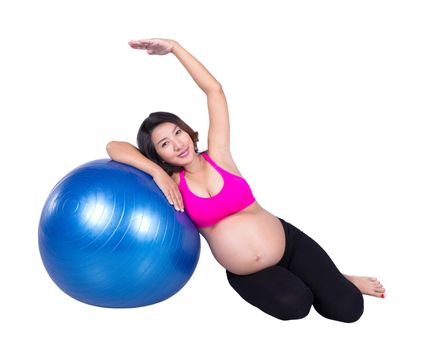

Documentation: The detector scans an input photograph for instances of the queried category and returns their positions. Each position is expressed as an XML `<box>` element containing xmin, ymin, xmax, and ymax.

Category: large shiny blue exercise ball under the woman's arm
<box><xmin>38</xmin><ymin>159</ymin><xmax>200</xmax><ymax>308</ymax></box>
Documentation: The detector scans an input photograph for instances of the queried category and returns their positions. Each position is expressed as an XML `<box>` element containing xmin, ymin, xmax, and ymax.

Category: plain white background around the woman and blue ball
<box><xmin>0</xmin><ymin>0</ymin><xmax>422</xmax><ymax>349</ymax></box>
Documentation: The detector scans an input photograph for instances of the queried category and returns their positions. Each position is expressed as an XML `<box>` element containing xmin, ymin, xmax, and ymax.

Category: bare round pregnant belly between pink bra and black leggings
<box><xmin>200</xmin><ymin>202</ymin><xmax>285</xmax><ymax>275</ymax></box>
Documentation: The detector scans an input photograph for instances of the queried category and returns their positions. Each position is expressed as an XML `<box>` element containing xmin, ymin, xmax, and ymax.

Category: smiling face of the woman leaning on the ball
<box><xmin>151</xmin><ymin>122</ymin><xmax>195</xmax><ymax>166</ymax></box>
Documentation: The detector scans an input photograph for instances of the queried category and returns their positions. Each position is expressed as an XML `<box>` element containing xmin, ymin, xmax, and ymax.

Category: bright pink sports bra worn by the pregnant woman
<box><xmin>179</xmin><ymin>152</ymin><xmax>255</xmax><ymax>228</ymax></box>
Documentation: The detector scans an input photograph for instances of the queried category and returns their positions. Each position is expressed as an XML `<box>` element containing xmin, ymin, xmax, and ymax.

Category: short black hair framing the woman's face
<box><xmin>136</xmin><ymin>112</ymin><xmax>199</xmax><ymax>176</ymax></box>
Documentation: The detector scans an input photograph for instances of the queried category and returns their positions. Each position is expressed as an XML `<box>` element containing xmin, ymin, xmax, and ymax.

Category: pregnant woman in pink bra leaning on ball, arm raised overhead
<box><xmin>107</xmin><ymin>38</ymin><xmax>385</xmax><ymax>322</ymax></box>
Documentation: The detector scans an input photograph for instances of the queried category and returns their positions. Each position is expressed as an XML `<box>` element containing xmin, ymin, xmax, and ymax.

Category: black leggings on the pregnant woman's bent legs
<box><xmin>226</xmin><ymin>218</ymin><xmax>363</xmax><ymax>322</ymax></box>
